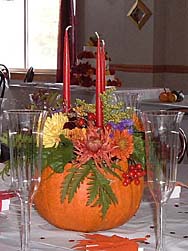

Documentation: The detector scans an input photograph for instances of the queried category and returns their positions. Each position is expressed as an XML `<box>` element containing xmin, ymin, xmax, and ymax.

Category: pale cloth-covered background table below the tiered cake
<box><xmin>5</xmin><ymin>81</ymin><xmax>166</xmax><ymax>108</ymax></box>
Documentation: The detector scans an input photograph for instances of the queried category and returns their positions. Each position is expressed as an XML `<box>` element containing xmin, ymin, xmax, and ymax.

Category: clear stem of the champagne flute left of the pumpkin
<box><xmin>21</xmin><ymin>199</ymin><xmax>31</xmax><ymax>251</ymax></box>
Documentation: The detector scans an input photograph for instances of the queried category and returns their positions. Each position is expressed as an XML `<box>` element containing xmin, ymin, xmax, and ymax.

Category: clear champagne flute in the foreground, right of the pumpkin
<box><xmin>142</xmin><ymin>110</ymin><xmax>184</xmax><ymax>251</ymax></box>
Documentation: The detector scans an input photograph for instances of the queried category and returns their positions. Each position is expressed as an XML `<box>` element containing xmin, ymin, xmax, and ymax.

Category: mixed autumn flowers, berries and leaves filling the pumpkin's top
<box><xmin>27</xmin><ymin>88</ymin><xmax>145</xmax><ymax>217</ymax></box>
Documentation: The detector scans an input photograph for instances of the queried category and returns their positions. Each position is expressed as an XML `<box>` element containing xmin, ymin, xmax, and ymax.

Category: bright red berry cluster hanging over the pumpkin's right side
<box><xmin>122</xmin><ymin>163</ymin><xmax>146</xmax><ymax>186</ymax></box>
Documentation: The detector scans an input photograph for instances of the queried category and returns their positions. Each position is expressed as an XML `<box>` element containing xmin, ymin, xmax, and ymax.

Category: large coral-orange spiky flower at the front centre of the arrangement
<box><xmin>72</xmin><ymin>124</ymin><xmax>113</xmax><ymax>167</ymax></box>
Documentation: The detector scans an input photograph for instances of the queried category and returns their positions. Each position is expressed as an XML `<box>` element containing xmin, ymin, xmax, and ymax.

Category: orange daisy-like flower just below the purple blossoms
<box><xmin>112</xmin><ymin>129</ymin><xmax>134</xmax><ymax>161</ymax></box>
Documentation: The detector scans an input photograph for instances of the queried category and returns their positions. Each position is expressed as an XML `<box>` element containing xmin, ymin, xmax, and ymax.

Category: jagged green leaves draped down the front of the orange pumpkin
<box><xmin>61</xmin><ymin>159</ymin><xmax>117</xmax><ymax>218</ymax></box>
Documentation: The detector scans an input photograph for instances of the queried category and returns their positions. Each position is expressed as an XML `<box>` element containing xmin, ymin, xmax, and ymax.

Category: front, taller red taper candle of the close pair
<box><xmin>95</xmin><ymin>32</ymin><xmax>103</xmax><ymax>127</ymax></box>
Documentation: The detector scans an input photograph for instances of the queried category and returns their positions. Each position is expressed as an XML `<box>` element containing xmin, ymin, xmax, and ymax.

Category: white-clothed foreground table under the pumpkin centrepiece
<box><xmin>0</xmin><ymin>165</ymin><xmax>188</xmax><ymax>251</ymax></box>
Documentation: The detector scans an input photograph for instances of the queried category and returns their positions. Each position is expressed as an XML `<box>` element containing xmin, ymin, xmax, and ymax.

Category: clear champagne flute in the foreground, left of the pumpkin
<box><xmin>6</xmin><ymin>110</ymin><xmax>47</xmax><ymax>251</ymax></box>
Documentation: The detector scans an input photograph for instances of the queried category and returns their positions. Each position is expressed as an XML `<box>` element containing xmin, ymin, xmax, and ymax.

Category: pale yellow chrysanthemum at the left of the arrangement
<box><xmin>43</xmin><ymin>112</ymin><xmax>68</xmax><ymax>148</ymax></box>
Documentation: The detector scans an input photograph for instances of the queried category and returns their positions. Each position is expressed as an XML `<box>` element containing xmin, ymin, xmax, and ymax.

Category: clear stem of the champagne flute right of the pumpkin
<box><xmin>156</xmin><ymin>203</ymin><xmax>165</xmax><ymax>251</ymax></box>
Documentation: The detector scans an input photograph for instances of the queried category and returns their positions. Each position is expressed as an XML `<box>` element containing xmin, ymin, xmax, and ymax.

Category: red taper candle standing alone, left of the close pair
<box><xmin>63</xmin><ymin>25</ymin><xmax>71</xmax><ymax>112</ymax></box>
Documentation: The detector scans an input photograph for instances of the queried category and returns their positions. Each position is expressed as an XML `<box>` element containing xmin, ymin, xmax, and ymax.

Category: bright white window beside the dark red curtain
<box><xmin>0</xmin><ymin>0</ymin><xmax>59</xmax><ymax>69</ymax></box>
